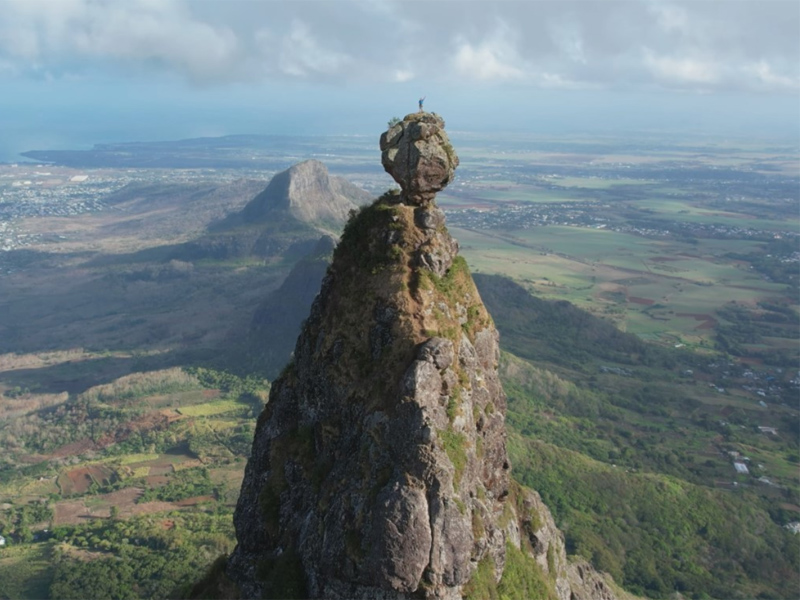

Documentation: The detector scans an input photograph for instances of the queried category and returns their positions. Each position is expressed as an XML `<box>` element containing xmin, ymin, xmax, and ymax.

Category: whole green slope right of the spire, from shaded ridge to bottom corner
<box><xmin>476</xmin><ymin>276</ymin><xmax>798</xmax><ymax>598</ymax></box>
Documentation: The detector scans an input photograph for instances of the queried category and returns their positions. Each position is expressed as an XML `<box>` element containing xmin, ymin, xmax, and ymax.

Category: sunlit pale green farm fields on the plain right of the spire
<box><xmin>452</xmin><ymin>226</ymin><xmax>786</xmax><ymax>342</ymax></box>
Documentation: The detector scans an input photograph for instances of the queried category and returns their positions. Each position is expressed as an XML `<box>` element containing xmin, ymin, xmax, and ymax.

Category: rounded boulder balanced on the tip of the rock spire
<box><xmin>380</xmin><ymin>112</ymin><xmax>458</xmax><ymax>206</ymax></box>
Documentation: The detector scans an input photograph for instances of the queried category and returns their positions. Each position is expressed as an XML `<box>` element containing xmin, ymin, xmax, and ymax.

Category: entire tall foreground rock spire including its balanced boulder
<box><xmin>226</xmin><ymin>113</ymin><xmax>614</xmax><ymax>600</ymax></box>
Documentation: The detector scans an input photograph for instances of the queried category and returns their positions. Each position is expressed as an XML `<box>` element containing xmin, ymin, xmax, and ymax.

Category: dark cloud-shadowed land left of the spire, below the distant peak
<box><xmin>0</xmin><ymin>251</ymin><xmax>287</xmax><ymax>354</ymax></box>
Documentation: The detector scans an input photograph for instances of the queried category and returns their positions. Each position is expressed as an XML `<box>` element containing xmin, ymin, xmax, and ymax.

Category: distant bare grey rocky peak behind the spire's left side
<box><xmin>242</xmin><ymin>160</ymin><xmax>370</xmax><ymax>232</ymax></box>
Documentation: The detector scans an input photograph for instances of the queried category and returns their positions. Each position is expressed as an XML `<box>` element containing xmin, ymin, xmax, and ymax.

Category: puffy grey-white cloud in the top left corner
<box><xmin>0</xmin><ymin>0</ymin><xmax>240</xmax><ymax>81</ymax></box>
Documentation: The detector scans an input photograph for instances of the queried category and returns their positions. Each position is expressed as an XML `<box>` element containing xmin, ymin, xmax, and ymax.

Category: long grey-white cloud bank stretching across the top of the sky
<box><xmin>0</xmin><ymin>0</ymin><xmax>800</xmax><ymax>94</ymax></box>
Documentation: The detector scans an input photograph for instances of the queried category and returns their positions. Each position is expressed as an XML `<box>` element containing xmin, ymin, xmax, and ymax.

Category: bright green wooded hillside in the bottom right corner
<box><xmin>509</xmin><ymin>434</ymin><xmax>800</xmax><ymax>598</ymax></box>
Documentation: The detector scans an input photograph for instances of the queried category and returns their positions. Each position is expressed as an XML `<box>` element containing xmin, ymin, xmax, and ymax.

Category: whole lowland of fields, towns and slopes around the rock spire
<box><xmin>0</xmin><ymin>133</ymin><xmax>800</xmax><ymax>598</ymax></box>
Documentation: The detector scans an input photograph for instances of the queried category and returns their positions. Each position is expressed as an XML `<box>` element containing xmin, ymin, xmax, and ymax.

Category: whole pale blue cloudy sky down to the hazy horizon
<box><xmin>0</xmin><ymin>0</ymin><xmax>800</xmax><ymax>160</ymax></box>
